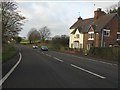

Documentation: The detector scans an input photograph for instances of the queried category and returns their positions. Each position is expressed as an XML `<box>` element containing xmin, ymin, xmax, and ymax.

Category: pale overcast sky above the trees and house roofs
<box><xmin>17</xmin><ymin>0</ymin><xmax>118</xmax><ymax>37</ymax></box>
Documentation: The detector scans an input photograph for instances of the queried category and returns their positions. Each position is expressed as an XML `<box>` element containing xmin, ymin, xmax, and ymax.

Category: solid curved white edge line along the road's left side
<box><xmin>0</xmin><ymin>52</ymin><xmax>22</xmax><ymax>86</ymax></box>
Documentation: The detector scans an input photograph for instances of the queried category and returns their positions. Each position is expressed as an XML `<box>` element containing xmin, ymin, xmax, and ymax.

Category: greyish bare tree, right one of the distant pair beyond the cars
<box><xmin>39</xmin><ymin>26</ymin><xmax>51</xmax><ymax>41</ymax></box>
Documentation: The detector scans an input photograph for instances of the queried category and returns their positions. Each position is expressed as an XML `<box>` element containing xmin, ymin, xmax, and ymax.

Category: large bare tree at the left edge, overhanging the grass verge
<box><xmin>0</xmin><ymin>1</ymin><xmax>25</xmax><ymax>43</ymax></box>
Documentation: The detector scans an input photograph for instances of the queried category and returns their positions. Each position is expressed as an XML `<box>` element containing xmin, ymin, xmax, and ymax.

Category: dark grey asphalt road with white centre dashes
<box><xmin>2</xmin><ymin>46</ymin><xmax>118</xmax><ymax>88</ymax></box>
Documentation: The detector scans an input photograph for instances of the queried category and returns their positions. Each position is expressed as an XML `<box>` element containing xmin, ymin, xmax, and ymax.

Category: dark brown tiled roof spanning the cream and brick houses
<box><xmin>70</xmin><ymin>13</ymin><xmax>117</xmax><ymax>33</ymax></box>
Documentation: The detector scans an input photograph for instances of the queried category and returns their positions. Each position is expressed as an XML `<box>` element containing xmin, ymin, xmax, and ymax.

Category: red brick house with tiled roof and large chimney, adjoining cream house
<box><xmin>70</xmin><ymin>8</ymin><xmax>120</xmax><ymax>50</ymax></box>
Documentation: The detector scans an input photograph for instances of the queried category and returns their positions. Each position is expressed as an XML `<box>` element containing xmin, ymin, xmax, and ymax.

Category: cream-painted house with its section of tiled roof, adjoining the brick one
<box><xmin>69</xmin><ymin>17</ymin><xmax>93</xmax><ymax>49</ymax></box>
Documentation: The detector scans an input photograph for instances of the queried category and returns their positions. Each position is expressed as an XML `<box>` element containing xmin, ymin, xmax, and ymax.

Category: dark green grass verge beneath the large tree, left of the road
<box><xmin>2</xmin><ymin>44</ymin><xmax>17</xmax><ymax>63</ymax></box>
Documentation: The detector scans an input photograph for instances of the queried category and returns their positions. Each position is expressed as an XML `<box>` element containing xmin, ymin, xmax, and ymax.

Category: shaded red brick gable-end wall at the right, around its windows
<box><xmin>104</xmin><ymin>17</ymin><xmax>118</xmax><ymax>47</ymax></box>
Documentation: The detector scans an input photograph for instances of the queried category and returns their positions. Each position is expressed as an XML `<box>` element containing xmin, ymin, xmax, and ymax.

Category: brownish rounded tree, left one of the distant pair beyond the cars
<box><xmin>28</xmin><ymin>28</ymin><xmax>40</xmax><ymax>43</ymax></box>
